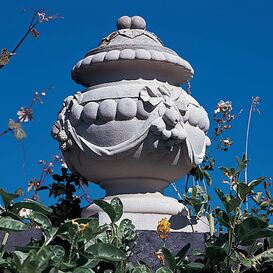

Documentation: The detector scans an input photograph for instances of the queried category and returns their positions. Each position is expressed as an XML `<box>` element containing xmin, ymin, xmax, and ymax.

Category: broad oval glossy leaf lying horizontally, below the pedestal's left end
<box><xmin>85</xmin><ymin>243</ymin><xmax>126</xmax><ymax>262</ymax></box>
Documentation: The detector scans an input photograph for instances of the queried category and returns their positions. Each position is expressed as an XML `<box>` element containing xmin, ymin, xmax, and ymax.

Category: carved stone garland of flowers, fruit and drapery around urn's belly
<box><xmin>52</xmin><ymin>85</ymin><xmax>205</xmax><ymax>164</ymax></box>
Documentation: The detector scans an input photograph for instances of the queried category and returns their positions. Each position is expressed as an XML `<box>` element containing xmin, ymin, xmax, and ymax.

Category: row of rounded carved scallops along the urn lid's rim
<box><xmin>72</xmin><ymin>48</ymin><xmax>194</xmax><ymax>75</ymax></box>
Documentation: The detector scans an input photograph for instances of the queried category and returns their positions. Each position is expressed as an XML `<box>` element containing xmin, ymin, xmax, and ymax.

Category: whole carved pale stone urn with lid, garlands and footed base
<box><xmin>52</xmin><ymin>16</ymin><xmax>210</xmax><ymax>229</ymax></box>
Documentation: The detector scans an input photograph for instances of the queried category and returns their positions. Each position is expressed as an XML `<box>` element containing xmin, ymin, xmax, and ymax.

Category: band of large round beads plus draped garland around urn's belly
<box><xmin>52</xmin><ymin>84</ymin><xmax>210</xmax><ymax>165</ymax></box>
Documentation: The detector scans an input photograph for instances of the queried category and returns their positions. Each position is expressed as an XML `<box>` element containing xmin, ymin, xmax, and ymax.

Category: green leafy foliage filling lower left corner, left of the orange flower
<box><xmin>0</xmin><ymin>196</ymin><xmax>136</xmax><ymax>273</ymax></box>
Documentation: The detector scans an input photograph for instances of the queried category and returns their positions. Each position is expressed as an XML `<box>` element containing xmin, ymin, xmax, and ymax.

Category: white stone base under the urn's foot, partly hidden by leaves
<box><xmin>82</xmin><ymin>192</ymin><xmax>209</xmax><ymax>232</ymax></box>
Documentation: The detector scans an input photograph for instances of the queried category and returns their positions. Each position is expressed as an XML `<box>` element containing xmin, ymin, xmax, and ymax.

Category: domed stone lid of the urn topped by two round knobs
<box><xmin>72</xmin><ymin>16</ymin><xmax>194</xmax><ymax>87</ymax></box>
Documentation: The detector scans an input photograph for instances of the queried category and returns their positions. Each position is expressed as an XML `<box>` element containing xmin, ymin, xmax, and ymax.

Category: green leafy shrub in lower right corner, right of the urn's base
<box><xmin>199</xmin><ymin>156</ymin><xmax>273</xmax><ymax>273</ymax></box>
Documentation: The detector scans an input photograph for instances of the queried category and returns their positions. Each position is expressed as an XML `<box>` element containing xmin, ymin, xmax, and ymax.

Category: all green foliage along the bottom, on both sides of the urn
<box><xmin>0</xmin><ymin>152</ymin><xmax>273</xmax><ymax>273</ymax></box>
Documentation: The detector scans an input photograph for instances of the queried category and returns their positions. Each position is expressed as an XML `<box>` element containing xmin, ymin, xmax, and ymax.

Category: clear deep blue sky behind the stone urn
<box><xmin>0</xmin><ymin>0</ymin><xmax>273</xmax><ymax>204</ymax></box>
